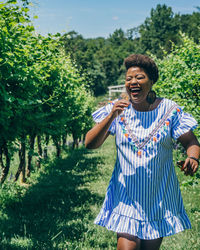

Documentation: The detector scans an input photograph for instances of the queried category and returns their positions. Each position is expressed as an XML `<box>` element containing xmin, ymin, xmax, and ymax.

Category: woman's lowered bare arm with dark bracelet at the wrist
<box><xmin>178</xmin><ymin>130</ymin><xmax>200</xmax><ymax>176</ymax></box>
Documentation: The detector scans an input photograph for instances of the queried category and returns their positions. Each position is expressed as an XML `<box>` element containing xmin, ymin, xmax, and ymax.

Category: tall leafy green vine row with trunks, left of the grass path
<box><xmin>0</xmin><ymin>0</ymin><xmax>93</xmax><ymax>183</ymax></box>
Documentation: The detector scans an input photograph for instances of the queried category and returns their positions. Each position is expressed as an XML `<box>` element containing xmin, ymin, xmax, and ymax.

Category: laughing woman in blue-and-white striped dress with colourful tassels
<box><xmin>85</xmin><ymin>55</ymin><xmax>200</xmax><ymax>250</ymax></box>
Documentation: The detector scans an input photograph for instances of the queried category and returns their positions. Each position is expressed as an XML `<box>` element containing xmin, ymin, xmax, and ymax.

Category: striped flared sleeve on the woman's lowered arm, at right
<box><xmin>172</xmin><ymin>108</ymin><xmax>197</xmax><ymax>140</ymax></box>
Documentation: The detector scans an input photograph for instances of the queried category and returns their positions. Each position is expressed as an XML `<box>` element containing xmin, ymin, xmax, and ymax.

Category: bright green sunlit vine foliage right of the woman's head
<box><xmin>154</xmin><ymin>34</ymin><xmax>200</xmax><ymax>134</ymax></box>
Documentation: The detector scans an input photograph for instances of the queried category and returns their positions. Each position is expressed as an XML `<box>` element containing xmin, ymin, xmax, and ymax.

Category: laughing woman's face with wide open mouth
<box><xmin>125</xmin><ymin>67</ymin><xmax>153</xmax><ymax>104</ymax></box>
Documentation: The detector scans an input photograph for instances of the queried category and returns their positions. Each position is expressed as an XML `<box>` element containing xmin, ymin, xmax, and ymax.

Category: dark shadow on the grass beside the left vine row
<box><xmin>0</xmin><ymin>149</ymin><xmax>103</xmax><ymax>249</ymax></box>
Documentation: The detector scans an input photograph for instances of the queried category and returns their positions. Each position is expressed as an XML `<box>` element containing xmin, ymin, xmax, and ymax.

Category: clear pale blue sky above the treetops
<box><xmin>31</xmin><ymin>0</ymin><xmax>200</xmax><ymax>38</ymax></box>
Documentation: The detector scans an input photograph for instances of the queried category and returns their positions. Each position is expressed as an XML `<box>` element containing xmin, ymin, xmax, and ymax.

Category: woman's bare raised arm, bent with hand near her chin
<box><xmin>85</xmin><ymin>100</ymin><xmax>129</xmax><ymax>149</ymax></box>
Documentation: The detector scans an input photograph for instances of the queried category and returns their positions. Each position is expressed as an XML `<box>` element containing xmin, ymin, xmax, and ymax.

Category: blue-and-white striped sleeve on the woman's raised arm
<box><xmin>92</xmin><ymin>102</ymin><xmax>116</xmax><ymax>135</ymax></box>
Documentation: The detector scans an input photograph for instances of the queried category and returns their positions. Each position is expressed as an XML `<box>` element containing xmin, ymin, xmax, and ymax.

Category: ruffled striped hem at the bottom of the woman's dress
<box><xmin>94</xmin><ymin>210</ymin><xmax>191</xmax><ymax>240</ymax></box>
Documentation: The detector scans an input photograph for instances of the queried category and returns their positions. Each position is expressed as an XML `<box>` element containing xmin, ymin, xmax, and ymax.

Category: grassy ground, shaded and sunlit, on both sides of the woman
<box><xmin>0</xmin><ymin>137</ymin><xmax>200</xmax><ymax>250</ymax></box>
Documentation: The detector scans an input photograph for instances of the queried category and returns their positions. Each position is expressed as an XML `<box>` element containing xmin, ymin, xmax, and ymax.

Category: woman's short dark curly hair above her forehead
<box><xmin>124</xmin><ymin>54</ymin><xmax>159</xmax><ymax>83</ymax></box>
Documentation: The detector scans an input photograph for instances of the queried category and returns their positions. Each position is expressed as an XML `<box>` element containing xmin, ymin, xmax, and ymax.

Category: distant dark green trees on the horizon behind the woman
<box><xmin>62</xmin><ymin>4</ymin><xmax>200</xmax><ymax>96</ymax></box>
